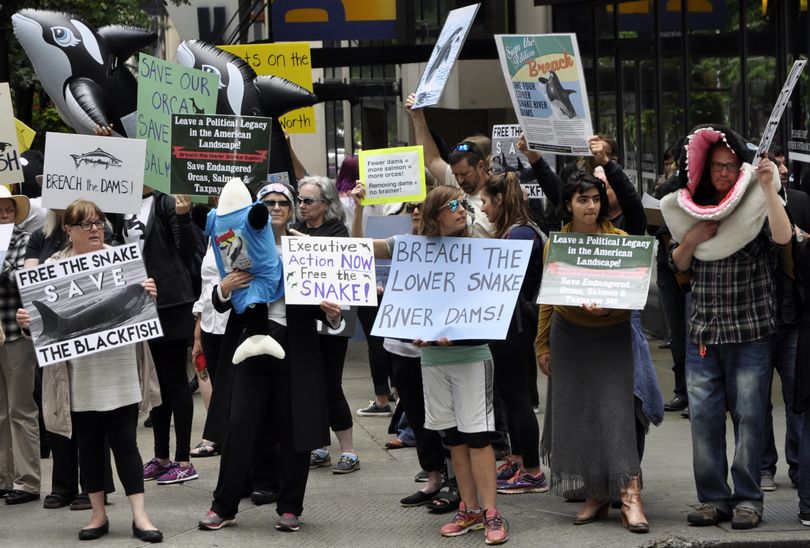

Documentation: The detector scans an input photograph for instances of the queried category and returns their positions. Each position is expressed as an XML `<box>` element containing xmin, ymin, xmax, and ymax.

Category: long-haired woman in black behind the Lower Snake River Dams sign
<box><xmin>481</xmin><ymin>171</ymin><xmax>548</xmax><ymax>494</ymax></box>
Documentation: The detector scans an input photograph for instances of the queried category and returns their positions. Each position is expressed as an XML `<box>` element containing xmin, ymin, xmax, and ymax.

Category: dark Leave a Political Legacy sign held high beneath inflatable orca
<box><xmin>172</xmin><ymin>114</ymin><xmax>272</xmax><ymax>196</ymax></box>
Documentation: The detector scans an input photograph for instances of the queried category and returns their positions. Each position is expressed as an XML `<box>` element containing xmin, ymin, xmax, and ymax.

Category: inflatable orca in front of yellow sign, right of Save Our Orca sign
<box><xmin>177</xmin><ymin>40</ymin><xmax>318</xmax><ymax>186</ymax></box>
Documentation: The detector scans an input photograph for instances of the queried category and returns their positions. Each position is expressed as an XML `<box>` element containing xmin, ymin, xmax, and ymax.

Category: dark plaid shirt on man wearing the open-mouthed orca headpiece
<box><xmin>669</xmin><ymin>225</ymin><xmax>779</xmax><ymax>345</ymax></box>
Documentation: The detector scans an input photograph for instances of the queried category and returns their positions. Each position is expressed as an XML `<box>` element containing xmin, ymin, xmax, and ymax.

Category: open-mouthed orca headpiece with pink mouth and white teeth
<box><xmin>661</xmin><ymin>125</ymin><xmax>781</xmax><ymax>261</ymax></box>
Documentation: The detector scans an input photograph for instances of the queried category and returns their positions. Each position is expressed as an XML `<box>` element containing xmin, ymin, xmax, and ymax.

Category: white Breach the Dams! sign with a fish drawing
<box><xmin>42</xmin><ymin>132</ymin><xmax>146</xmax><ymax>213</ymax></box>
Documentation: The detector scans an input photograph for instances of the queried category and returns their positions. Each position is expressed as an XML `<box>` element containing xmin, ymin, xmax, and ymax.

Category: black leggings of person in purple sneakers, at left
<box><xmin>149</xmin><ymin>338</ymin><xmax>194</xmax><ymax>462</ymax></box>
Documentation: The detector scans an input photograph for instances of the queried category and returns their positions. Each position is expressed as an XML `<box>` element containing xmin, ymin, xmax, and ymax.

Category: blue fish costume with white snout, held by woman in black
<box><xmin>205</xmin><ymin>178</ymin><xmax>284</xmax><ymax>364</ymax></box>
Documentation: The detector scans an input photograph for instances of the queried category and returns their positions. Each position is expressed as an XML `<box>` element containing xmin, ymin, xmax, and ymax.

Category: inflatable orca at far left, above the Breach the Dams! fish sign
<box><xmin>11</xmin><ymin>9</ymin><xmax>157</xmax><ymax>137</ymax></box>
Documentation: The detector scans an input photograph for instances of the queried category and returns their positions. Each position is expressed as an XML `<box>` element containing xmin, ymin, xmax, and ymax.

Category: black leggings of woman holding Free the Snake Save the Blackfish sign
<box><xmin>71</xmin><ymin>403</ymin><xmax>143</xmax><ymax>496</ymax></box>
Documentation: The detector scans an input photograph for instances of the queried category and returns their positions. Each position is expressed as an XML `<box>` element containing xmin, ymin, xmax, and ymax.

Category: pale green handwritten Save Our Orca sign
<box><xmin>137</xmin><ymin>53</ymin><xmax>219</xmax><ymax>192</ymax></box>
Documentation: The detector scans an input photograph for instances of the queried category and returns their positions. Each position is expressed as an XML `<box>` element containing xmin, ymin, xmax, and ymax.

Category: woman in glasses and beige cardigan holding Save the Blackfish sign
<box><xmin>17</xmin><ymin>200</ymin><xmax>163</xmax><ymax>542</ymax></box>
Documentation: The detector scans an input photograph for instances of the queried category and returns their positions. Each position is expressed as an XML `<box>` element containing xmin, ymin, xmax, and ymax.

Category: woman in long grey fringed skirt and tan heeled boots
<box><xmin>535</xmin><ymin>174</ymin><xmax>650</xmax><ymax>533</ymax></box>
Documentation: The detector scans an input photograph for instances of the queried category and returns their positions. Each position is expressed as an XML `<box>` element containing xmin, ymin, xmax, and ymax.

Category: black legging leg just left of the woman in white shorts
<box><xmin>391</xmin><ymin>354</ymin><xmax>444</xmax><ymax>472</ymax></box>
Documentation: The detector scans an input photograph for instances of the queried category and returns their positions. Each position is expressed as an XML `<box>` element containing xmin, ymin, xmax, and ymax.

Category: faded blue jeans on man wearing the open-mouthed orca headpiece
<box><xmin>686</xmin><ymin>337</ymin><xmax>771</xmax><ymax>516</ymax></box>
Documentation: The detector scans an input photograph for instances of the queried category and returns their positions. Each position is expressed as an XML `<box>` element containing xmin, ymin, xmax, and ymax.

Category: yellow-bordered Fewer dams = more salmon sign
<box><xmin>358</xmin><ymin>145</ymin><xmax>425</xmax><ymax>205</ymax></box>
